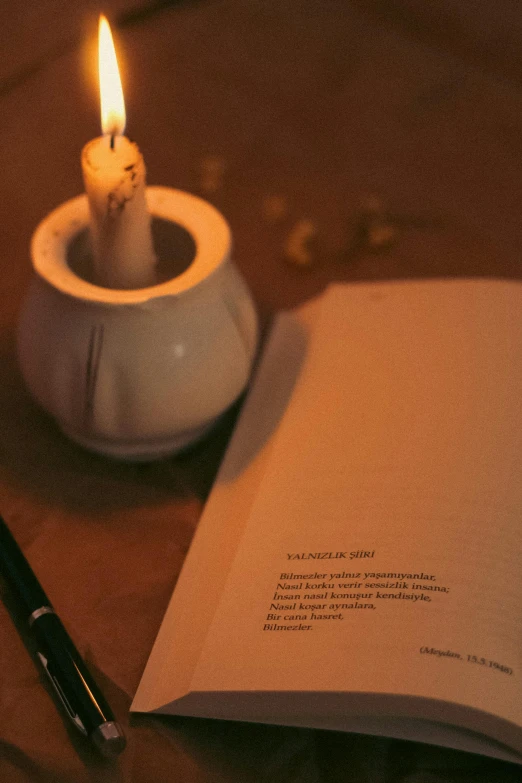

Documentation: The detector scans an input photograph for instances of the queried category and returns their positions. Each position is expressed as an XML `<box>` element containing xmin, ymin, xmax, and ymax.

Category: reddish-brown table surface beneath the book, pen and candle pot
<box><xmin>0</xmin><ymin>0</ymin><xmax>522</xmax><ymax>783</ymax></box>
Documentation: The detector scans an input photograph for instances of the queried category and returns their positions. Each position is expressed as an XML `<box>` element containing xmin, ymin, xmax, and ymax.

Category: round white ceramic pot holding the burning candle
<box><xmin>18</xmin><ymin>187</ymin><xmax>258</xmax><ymax>460</ymax></box>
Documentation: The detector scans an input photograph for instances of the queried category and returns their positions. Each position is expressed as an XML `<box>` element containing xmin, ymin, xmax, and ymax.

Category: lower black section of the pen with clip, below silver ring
<box><xmin>31</xmin><ymin>613</ymin><xmax>114</xmax><ymax>736</ymax></box>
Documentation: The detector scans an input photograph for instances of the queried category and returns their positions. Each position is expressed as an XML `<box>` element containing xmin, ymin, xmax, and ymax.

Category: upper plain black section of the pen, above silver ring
<box><xmin>0</xmin><ymin>518</ymin><xmax>51</xmax><ymax>617</ymax></box>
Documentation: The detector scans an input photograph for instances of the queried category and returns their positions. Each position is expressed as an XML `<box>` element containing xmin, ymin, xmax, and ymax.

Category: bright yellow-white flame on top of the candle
<box><xmin>98</xmin><ymin>16</ymin><xmax>125</xmax><ymax>136</ymax></box>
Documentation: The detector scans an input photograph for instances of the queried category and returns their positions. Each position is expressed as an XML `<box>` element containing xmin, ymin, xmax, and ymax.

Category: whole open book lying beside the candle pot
<box><xmin>132</xmin><ymin>280</ymin><xmax>522</xmax><ymax>762</ymax></box>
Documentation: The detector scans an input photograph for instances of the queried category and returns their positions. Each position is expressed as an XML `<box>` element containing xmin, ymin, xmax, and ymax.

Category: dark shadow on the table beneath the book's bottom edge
<box><xmin>131</xmin><ymin>715</ymin><xmax>521</xmax><ymax>783</ymax></box>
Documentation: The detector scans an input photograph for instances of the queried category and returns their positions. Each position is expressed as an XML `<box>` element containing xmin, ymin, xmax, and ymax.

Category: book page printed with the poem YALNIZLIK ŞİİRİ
<box><xmin>190</xmin><ymin>281</ymin><xmax>522</xmax><ymax>739</ymax></box>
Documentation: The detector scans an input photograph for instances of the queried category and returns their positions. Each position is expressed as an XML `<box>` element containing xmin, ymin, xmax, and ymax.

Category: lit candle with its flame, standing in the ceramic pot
<box><xmin>81</xmin><ymin>16</ymin><xmax>156</xmax><ymax>288</ymax></box>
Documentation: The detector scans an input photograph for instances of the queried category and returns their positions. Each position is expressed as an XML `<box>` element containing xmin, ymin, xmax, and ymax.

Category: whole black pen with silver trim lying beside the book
<box><xmin>0</xmin><ymin>517</ymin><xmax>125</xmax><ymax>756</ymax></box>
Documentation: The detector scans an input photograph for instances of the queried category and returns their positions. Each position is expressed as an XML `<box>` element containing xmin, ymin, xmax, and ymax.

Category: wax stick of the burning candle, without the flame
<box><xmin>82</xmin><ymin>135</ymin><xmax>156</xmax><ymax>288</ymax></box>
